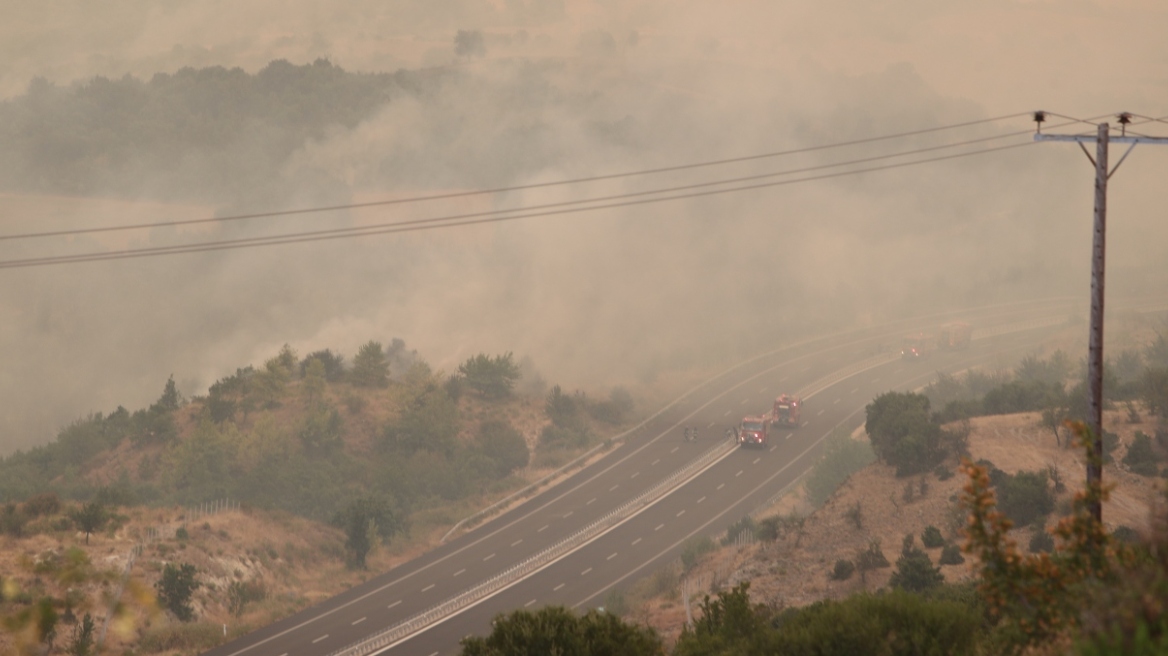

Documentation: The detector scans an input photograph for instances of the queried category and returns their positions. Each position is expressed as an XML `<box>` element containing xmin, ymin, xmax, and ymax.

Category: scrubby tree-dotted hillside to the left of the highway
<box><xmin>0</xmin><ymin>342</ymin><xmax>668</xmax><ymax>654</ymax></box>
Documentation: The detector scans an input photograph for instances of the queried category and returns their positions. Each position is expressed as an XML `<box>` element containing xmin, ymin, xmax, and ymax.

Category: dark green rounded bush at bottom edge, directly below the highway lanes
<box><xmin>461</xmin><ymin>606</ymin><xmax>665</xmax><ymax>656</ymax></box>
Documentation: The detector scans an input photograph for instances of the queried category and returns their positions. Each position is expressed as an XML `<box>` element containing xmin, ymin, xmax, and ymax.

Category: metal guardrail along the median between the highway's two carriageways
<box><xmin>329</xmin><ymin>434</ymin><xmax>735</xmax><ymax>656</ymax></box>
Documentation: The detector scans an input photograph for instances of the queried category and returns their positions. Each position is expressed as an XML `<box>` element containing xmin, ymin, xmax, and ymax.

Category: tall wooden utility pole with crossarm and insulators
<box><xmin>1034</xmin><ymin>112</ymin><xmax>1168</xmax><ymax>524</ymax></box>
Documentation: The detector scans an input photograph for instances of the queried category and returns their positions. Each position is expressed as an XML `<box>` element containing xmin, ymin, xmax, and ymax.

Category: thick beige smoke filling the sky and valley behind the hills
<box><xmin>0</xmin><ymin>0</ymin><xmax>1168</xmax><ymax>453</ymax></box>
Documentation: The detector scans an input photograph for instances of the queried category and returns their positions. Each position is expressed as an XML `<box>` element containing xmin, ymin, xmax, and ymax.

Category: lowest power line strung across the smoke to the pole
<box><xmin>0</xmin><ymin>141</ymin><xmax>1035</xmax><ymax>268</ymax></box>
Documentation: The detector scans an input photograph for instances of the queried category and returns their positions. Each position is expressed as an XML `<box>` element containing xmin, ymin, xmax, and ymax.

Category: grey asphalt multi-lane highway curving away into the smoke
<box><xmin>207</xmin><ymin>299</ymin><xmax>1102</xmax><ymax>656</ymax></box>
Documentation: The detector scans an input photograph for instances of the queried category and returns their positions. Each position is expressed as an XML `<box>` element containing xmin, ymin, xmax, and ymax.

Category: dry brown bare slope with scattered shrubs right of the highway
<box><xmin>628</xmin><ymin>411</ymin><xmax>1164</xmax><ymax>641</ymax></box>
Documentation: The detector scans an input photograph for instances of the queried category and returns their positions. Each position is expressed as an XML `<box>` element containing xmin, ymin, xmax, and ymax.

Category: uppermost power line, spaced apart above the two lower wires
<box><xmin>0</xmin><ymin>112</ymin><xmax>1032</xmax><ymax>242</ymax></box>
